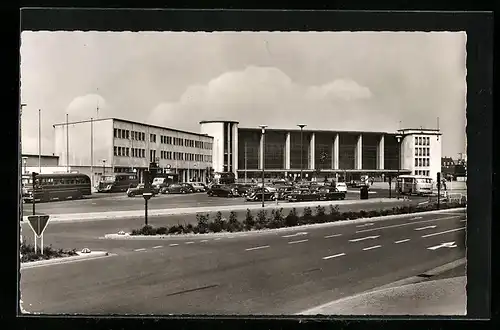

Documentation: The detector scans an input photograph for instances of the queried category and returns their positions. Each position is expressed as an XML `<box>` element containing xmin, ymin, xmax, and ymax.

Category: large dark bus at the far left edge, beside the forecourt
<box><xmin>21</xmin><ymin>173</ymin><xmax>92</xmax><ymax>202</ymax></box>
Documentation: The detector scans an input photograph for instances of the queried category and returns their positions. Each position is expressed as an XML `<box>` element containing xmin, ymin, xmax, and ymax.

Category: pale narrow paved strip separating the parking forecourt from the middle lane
<box><xmin>19</xmin><ymin>198</ymin><xmax>410</xmax><ymax>222</ymax></box>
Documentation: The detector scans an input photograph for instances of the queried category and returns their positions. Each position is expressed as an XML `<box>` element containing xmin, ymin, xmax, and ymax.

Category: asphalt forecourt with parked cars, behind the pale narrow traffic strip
<box><xmin>23</xmin><ymin>189</ymin><xmax>389</xmax><ymax>216</ymax></box>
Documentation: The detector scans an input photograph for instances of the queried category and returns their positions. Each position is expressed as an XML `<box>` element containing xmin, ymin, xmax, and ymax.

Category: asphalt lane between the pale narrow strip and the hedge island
<box><xmin>21</xmin><ymin>199</ymin><xmax>426</xmax><ymax>252</ymax></box>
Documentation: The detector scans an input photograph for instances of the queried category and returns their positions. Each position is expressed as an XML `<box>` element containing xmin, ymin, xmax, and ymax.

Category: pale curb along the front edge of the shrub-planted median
<box><xmin>101</xmin><ymin>208</ymin><xmax>466</xmax><ymax>240</ymax></box>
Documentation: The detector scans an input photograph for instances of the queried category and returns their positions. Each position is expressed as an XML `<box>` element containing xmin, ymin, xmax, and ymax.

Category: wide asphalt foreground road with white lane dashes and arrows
<box><xmin>21</xmin><ymin>212</ymin><xmax>466</xmax><ymax>315</ymax></box>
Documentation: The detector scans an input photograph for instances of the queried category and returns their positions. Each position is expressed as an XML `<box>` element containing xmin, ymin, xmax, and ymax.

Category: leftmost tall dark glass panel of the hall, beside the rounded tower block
<box><xmin>238</xmin><ymin>129</ymin><xmax>260</xmax><ymax>170</ymax></box>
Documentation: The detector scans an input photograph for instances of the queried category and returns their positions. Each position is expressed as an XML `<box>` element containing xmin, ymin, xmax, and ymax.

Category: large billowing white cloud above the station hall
<box><xmin>147</xmin><ymin>66</ymin><xmax>373</xmax><ymax>131</ymax></box>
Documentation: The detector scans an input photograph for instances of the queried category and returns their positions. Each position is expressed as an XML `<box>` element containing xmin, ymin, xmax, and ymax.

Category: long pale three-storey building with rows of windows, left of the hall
<box><xmin>53</xmin><ymin>118</ymin><xmax>213</xmax><ymax>183</ymax></box>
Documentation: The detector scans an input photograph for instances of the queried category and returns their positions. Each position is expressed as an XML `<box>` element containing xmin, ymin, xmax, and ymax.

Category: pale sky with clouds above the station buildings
<box><xmin>20</xmin><ymin>31</ymin><xmax>466</xmax><ymax>158</ymax></box>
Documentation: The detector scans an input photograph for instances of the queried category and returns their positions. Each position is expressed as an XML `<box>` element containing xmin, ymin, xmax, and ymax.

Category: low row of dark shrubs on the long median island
<box><xmin>131</xmin><ymin>203</ymin><xmax>466</xmax><ymax>235</ymax></box>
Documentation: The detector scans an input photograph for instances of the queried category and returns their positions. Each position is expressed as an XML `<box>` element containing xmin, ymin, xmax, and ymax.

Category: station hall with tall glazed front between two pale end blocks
<box><xmin>200</xmin><ymin>121</ymin><xmax>441</xmax><ymax>179</ymax></box>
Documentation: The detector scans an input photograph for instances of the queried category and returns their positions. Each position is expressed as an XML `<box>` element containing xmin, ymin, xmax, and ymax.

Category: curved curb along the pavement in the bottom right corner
<box><xmin>295</xmin><ymin>258</ymin><xmax>467</xmax><ymax>315</ymax></box>
